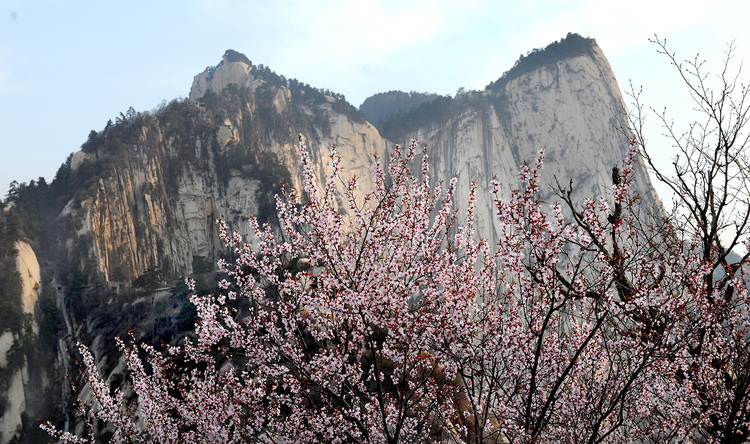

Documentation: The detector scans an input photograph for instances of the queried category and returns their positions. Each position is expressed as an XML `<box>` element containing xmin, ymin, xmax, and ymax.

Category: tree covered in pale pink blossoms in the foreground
<box><xmin>46</xmin><ymin>40</ymin><xmax>750</xmax><ymax>443</ymax></box>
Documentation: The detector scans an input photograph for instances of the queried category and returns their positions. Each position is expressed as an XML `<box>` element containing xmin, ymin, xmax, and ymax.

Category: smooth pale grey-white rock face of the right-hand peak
<box><xmin>412</xmin><ymin>45</ymin><xmax>657</xmax><ymax>243</ymax></box>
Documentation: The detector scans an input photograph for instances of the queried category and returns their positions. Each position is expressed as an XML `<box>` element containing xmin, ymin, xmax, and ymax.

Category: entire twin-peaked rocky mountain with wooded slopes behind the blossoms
<box><xmin>0</xmin><ymin>34</ymin><xmax>656</xmax><ymax>442</ymax></box>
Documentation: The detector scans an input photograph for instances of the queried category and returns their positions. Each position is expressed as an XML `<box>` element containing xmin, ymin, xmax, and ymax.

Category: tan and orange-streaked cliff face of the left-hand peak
<box><xmin>63</xmin><ymin>67</ymin><xmax>386</xmax><ymax>285</ymax></box>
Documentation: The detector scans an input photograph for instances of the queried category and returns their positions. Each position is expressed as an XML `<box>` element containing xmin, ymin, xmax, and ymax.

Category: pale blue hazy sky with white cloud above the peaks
<box><xmin>0</xmin><ymin>0</ymin><xmax>750</xmax><ymax>198</ymax></box>
